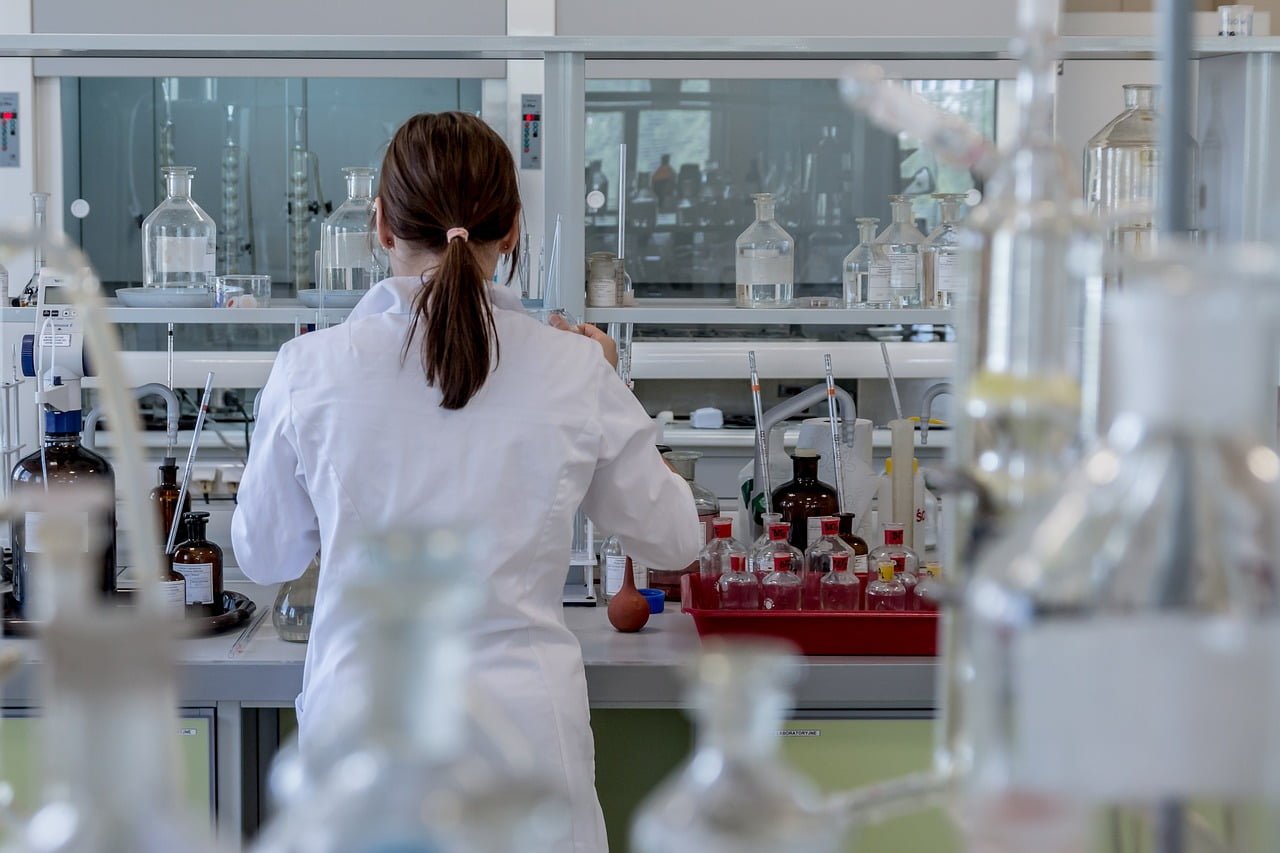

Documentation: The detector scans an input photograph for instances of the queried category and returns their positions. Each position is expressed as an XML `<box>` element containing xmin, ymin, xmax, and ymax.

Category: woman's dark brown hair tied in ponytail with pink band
<box><xmin>378</xmin><ymin>113</ymin><xmax>520</xmax><ymax>409</ymax></box>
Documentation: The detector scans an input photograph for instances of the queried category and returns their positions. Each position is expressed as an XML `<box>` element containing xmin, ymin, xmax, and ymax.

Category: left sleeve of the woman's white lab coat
<box><xmin>232</xmin><ymin>347</ymin><xmax>320</xmax><ymax>584</ymax></box>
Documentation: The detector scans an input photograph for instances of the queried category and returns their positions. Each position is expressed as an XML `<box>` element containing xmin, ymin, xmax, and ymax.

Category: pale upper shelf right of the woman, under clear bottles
<box><xmin>584</xmin><ymin>298</ymin><xmax>954</xmax><ymax>325</ymax></box>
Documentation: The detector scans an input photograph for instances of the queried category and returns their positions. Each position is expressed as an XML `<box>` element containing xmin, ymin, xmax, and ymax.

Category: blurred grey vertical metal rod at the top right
<box><xmin>1156</xmin><ymin>0</ymin><xmax>1192</xmax><ymax>234</ymax></box>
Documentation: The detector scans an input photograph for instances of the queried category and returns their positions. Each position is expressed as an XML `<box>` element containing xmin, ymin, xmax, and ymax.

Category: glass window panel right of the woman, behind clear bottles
<box><xmin>585</xmin><ymin>78</ymin><xmax>997</xmax><ymax>298</ymax></box>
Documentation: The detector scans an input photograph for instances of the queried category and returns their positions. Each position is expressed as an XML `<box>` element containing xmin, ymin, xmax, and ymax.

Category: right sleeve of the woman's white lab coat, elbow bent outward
<box><xmin>582</xmin><ymin>360</ymin><xmax>703</xmax><ymax>570</ymax></box>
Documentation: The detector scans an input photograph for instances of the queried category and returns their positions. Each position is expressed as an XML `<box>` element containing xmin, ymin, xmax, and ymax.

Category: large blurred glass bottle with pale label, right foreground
<box><xmin>963</xmin><ymin>247</ymin><xmax>1280</xmax><ymax>853</ymax></box>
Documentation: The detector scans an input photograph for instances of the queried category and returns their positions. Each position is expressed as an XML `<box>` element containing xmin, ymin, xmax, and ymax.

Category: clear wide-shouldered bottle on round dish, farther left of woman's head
<box><xmin>142</xmin><ymin>167</ymin><xmax>218</xmax><ymax>287</ymax></box>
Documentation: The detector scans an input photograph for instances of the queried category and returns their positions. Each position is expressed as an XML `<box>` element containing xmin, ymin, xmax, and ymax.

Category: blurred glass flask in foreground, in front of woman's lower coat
<box><xmin>253</xmin><ymin>530</ymin><xmax>568</xmax><ymax>853</ymax></box>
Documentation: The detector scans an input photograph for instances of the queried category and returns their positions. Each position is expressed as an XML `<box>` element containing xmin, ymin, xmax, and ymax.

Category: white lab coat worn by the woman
<box><xmin>232</xmin><ymin>278</ymin><xmax>701</xmax><ymax>853</ymax></box>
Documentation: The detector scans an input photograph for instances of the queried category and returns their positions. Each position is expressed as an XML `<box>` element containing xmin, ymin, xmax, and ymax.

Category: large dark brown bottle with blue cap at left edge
<box><xmin>4</xmin><ymin>411</ymin><xmax>115</xmax><ymax>619</ymax></box>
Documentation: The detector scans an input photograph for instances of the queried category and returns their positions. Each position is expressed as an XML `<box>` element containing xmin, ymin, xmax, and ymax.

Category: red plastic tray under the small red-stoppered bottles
<box><xmin>680</xmin><ymin>575</ymin><xmax>938</xmax><ymax>657</ymax></box>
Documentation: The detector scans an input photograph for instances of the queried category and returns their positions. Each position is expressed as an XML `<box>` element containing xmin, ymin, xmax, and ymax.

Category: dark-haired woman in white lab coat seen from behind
<box><xmin>232</xmin><ymin>113</ymin><xmax>701</xmax><ymax>853</ymax></box>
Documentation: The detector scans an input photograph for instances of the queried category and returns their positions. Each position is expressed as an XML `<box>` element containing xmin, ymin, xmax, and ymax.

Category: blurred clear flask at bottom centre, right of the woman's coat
<box><xmin>631</xmin><ymin>638</ymin><xmax>842</xmax><ymax>853</ymax></box>
